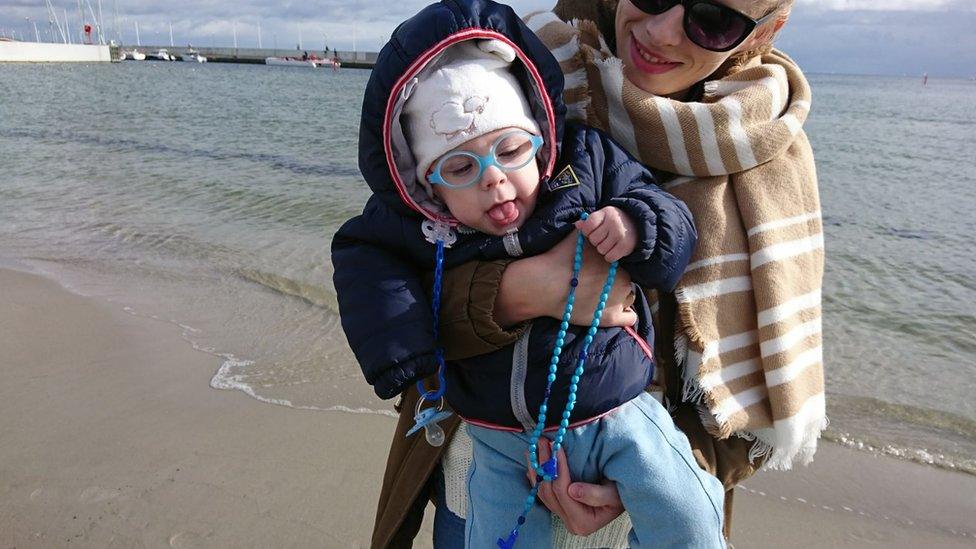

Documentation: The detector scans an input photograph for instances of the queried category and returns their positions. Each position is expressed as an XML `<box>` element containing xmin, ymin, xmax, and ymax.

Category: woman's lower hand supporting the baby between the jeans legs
<box><xmin>526</xmin><ymin>438</ymin><xmax>624</xmax><ymax>536</ymax></box>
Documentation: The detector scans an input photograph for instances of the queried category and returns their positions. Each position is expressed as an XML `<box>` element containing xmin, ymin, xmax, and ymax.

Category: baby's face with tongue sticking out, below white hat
<box><xmin>428</xmin><ymin>128</ymin><xmax>539</xmax><ymax>235</ymax></box>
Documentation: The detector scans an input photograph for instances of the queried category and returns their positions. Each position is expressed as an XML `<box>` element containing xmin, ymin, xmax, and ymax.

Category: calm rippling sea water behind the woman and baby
<box><xmin>0</xmin><ymin>62</ymin><xmax>976</xmax><ymax>474</ymax></box>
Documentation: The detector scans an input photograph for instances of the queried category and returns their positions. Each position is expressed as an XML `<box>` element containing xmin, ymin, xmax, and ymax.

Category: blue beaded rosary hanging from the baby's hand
<box><xmin>498</xmin><ymin>213</ymin><xmax>617</xmax><ymax>549</ymax></box>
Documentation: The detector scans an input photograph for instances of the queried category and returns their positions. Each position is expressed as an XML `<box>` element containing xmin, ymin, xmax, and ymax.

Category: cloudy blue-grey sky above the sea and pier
<box><xmin>0</xmin><ymin>0</ymin><xmax>976</xmax><ymax>78</ymax></box>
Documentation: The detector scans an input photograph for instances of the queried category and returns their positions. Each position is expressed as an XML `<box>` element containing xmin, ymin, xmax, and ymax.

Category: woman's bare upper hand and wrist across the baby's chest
<box><xmin>494</xmin><ymin>232</ymin><xmax>637</xmax><ymax>327</ymax></box>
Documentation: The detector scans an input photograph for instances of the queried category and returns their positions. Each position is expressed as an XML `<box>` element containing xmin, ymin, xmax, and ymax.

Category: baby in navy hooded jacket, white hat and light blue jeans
<box><xmin>333</xmin><ymin>2</ymin><xmax>724</xmax><ymax>547</ymax></box>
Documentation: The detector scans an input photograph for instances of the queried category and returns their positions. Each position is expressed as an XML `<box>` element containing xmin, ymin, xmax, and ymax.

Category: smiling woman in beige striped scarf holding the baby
<box><xmin>373</xmin><ymin>0</ymin><xmax>825</xmax><ymax>547</ymax></box>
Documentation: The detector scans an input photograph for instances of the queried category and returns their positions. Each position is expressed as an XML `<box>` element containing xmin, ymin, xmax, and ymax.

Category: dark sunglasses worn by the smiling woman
<box><xmin>630</xmin><ymin>0</ymin><xmax>777</xmax><ymax>52</ymax></box>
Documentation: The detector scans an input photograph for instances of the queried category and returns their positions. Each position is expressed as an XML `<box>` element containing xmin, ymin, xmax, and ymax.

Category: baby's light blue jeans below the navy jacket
<box><xmin>465</xmin><ymin>393</ymin><xmax>725</xmax><ymax>549</ymax></box>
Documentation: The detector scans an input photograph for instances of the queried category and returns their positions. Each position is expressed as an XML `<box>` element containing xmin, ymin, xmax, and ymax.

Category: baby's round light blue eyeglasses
<box><xmin>427</xmin><ymin>130</ymin><xmax>542</xmax><ymax>189</ymax></box>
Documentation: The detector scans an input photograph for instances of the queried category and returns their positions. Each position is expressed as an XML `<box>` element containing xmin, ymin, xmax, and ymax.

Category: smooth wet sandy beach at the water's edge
<box><xmin>0</xmin><ymin>267</ymin><xmax>976</xmax><ymax>548</ymax></box>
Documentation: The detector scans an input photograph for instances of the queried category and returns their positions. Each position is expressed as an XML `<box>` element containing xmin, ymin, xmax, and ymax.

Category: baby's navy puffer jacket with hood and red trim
<box><xmin>332</xmin><ymin>0</ymin><xmax>696</xmax><ymax>428</ymax></box>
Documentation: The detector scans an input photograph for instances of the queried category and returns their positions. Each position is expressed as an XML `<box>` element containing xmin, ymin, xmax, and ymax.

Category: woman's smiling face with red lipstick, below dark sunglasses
<box><xmin>615</xmin><ymin>0</ymin><xmax>782</xmax><ymax>99</ymax></box>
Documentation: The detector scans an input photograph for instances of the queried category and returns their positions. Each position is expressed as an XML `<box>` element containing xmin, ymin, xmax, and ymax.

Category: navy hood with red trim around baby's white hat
<box><xmin>359</xmin><ymin>0</ymin><xmax>566</xmax><ymax>226</ymax></box>
